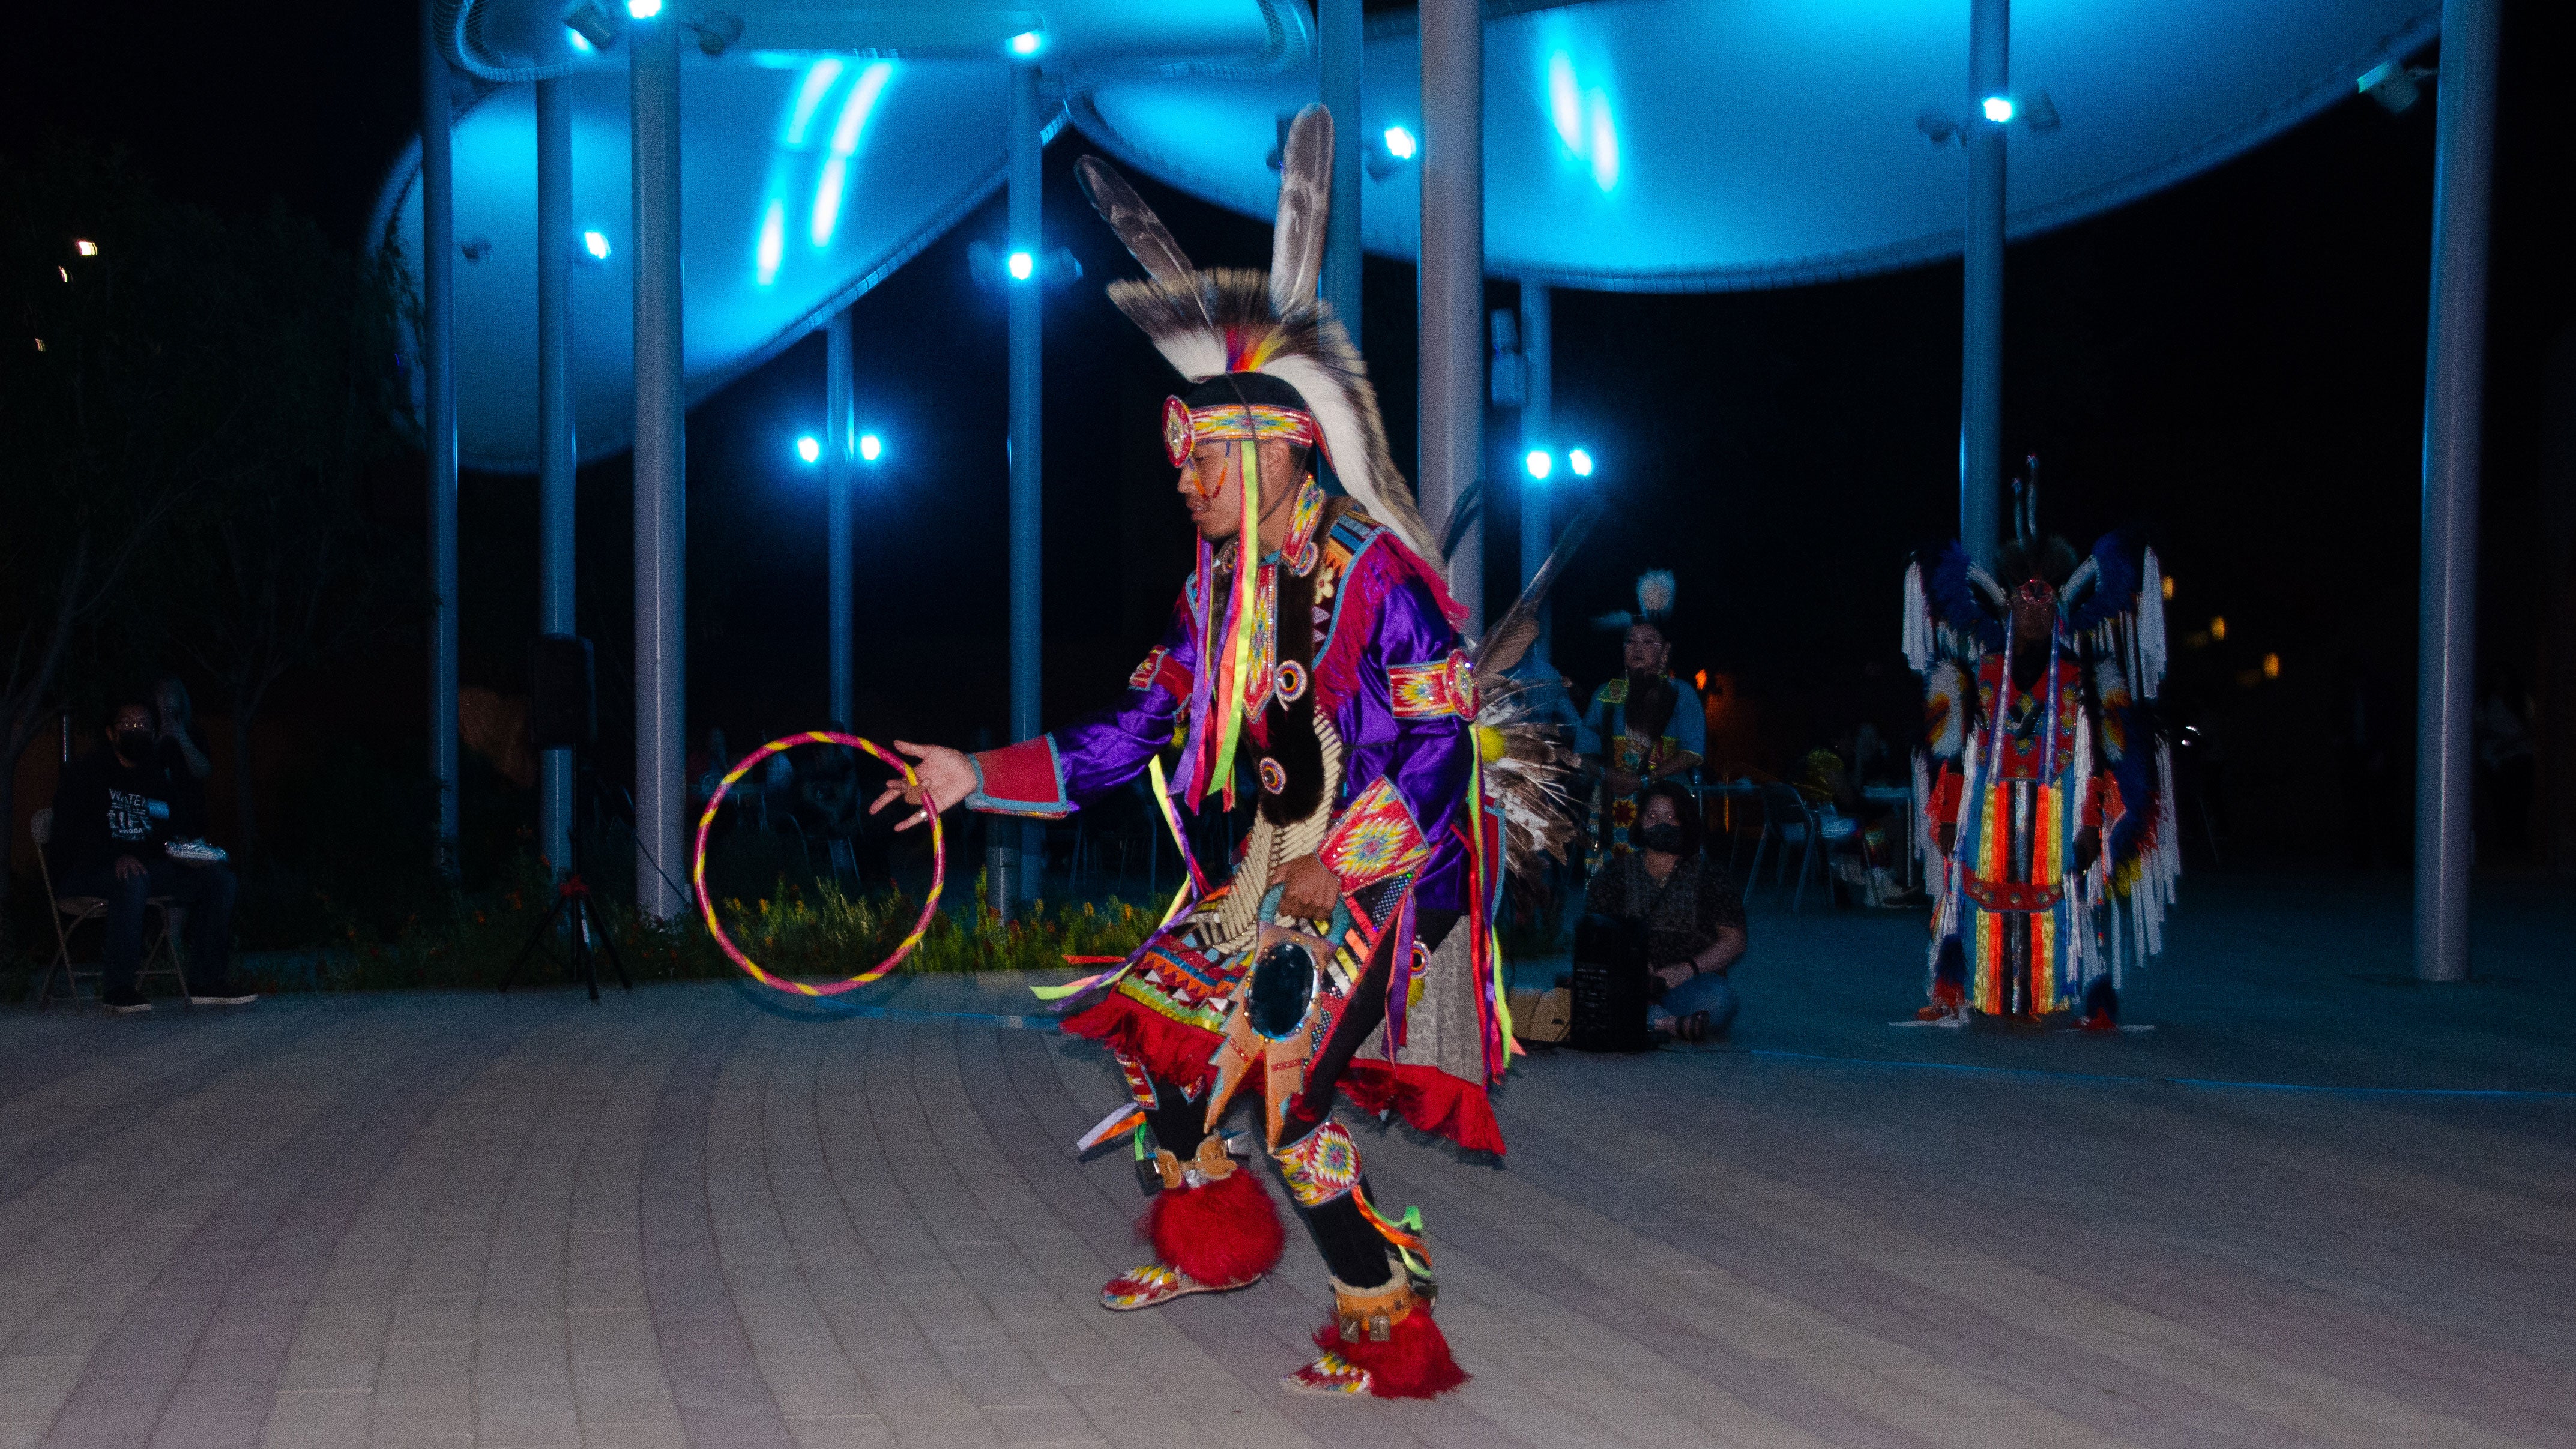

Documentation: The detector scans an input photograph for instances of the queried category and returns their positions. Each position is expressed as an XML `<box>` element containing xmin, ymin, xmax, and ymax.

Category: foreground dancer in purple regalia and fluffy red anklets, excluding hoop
<box><xmin>878</xmin><ymin>106</ymin><xmax>1572</xmax><ymax>1397</ymax></box>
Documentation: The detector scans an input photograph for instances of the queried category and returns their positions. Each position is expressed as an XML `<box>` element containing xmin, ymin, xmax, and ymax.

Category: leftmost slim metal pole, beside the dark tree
<box><xmin>420</xmin><ymin>0</ymin><xmax>459</xmax><ymax>875</ymax></box>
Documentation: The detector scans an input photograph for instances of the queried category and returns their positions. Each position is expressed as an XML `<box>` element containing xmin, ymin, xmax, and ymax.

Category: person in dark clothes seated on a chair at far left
<box><xmin>54</xmin><ymin>695</ymin><xmax>258</xmax><ymax>1011</ymax></box>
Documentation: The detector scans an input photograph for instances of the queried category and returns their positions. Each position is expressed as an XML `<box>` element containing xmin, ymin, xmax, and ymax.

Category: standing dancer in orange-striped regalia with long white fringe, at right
<box><xmin>1904</xmin><ymin>499</ymin><xmax>2182</xmax><ymax>1029</ymax></box>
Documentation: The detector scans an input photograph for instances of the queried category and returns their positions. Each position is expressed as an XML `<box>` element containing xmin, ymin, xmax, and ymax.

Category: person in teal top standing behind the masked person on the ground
<box><xmin>1576</xmin><ymin>569</ymin><xmax>1708</xmax><ymax>873</ymax></box>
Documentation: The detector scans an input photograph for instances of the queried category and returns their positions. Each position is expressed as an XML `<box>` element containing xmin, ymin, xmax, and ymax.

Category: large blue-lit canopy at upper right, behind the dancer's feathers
<box><xmin>1072</xmin><ymin>0</ymin><xmax>2440</xmax><ymax>291</ymax></box>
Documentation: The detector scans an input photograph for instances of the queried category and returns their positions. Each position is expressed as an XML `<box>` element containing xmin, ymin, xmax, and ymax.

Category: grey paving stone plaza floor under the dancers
<box><xmin>0</xmin><ymin>878</ymin><xmax>2576</xmax><ymax>1449</ymax></box>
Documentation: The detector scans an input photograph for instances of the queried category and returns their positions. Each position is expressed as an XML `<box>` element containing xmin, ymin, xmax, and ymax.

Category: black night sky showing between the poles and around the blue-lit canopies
<box><xmin>0</xmin><ymin>0</ymin><xmax>2576</xmax><ymax>854</ymax></box>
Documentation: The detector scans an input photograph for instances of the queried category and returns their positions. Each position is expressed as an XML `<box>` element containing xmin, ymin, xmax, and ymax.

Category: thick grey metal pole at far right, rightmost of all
<box><xmin>2416</xmin><ymin>0</ymin><xmax>2499</xmax><ymax>981</ymax></box>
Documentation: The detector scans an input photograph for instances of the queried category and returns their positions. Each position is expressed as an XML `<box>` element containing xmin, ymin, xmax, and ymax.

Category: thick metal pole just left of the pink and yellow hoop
<box><xmin>626</xmin><ymin>10</ymin><xmax>688</xmax><ymax>921</ymax></box>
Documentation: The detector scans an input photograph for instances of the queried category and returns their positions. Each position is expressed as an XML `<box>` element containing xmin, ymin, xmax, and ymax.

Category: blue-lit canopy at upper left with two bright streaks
<box><xmin>379</xmin><ymin>0</ymin><xmax>1309</xmax><ymax>471</ymax></box>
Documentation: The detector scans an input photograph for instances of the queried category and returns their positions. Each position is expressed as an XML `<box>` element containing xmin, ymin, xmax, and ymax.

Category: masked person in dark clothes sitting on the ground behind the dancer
<box><xmin>1584</xmin><ymin>780</ymin><xmax>1744</xmax><ymax>1043</ymax></box>
